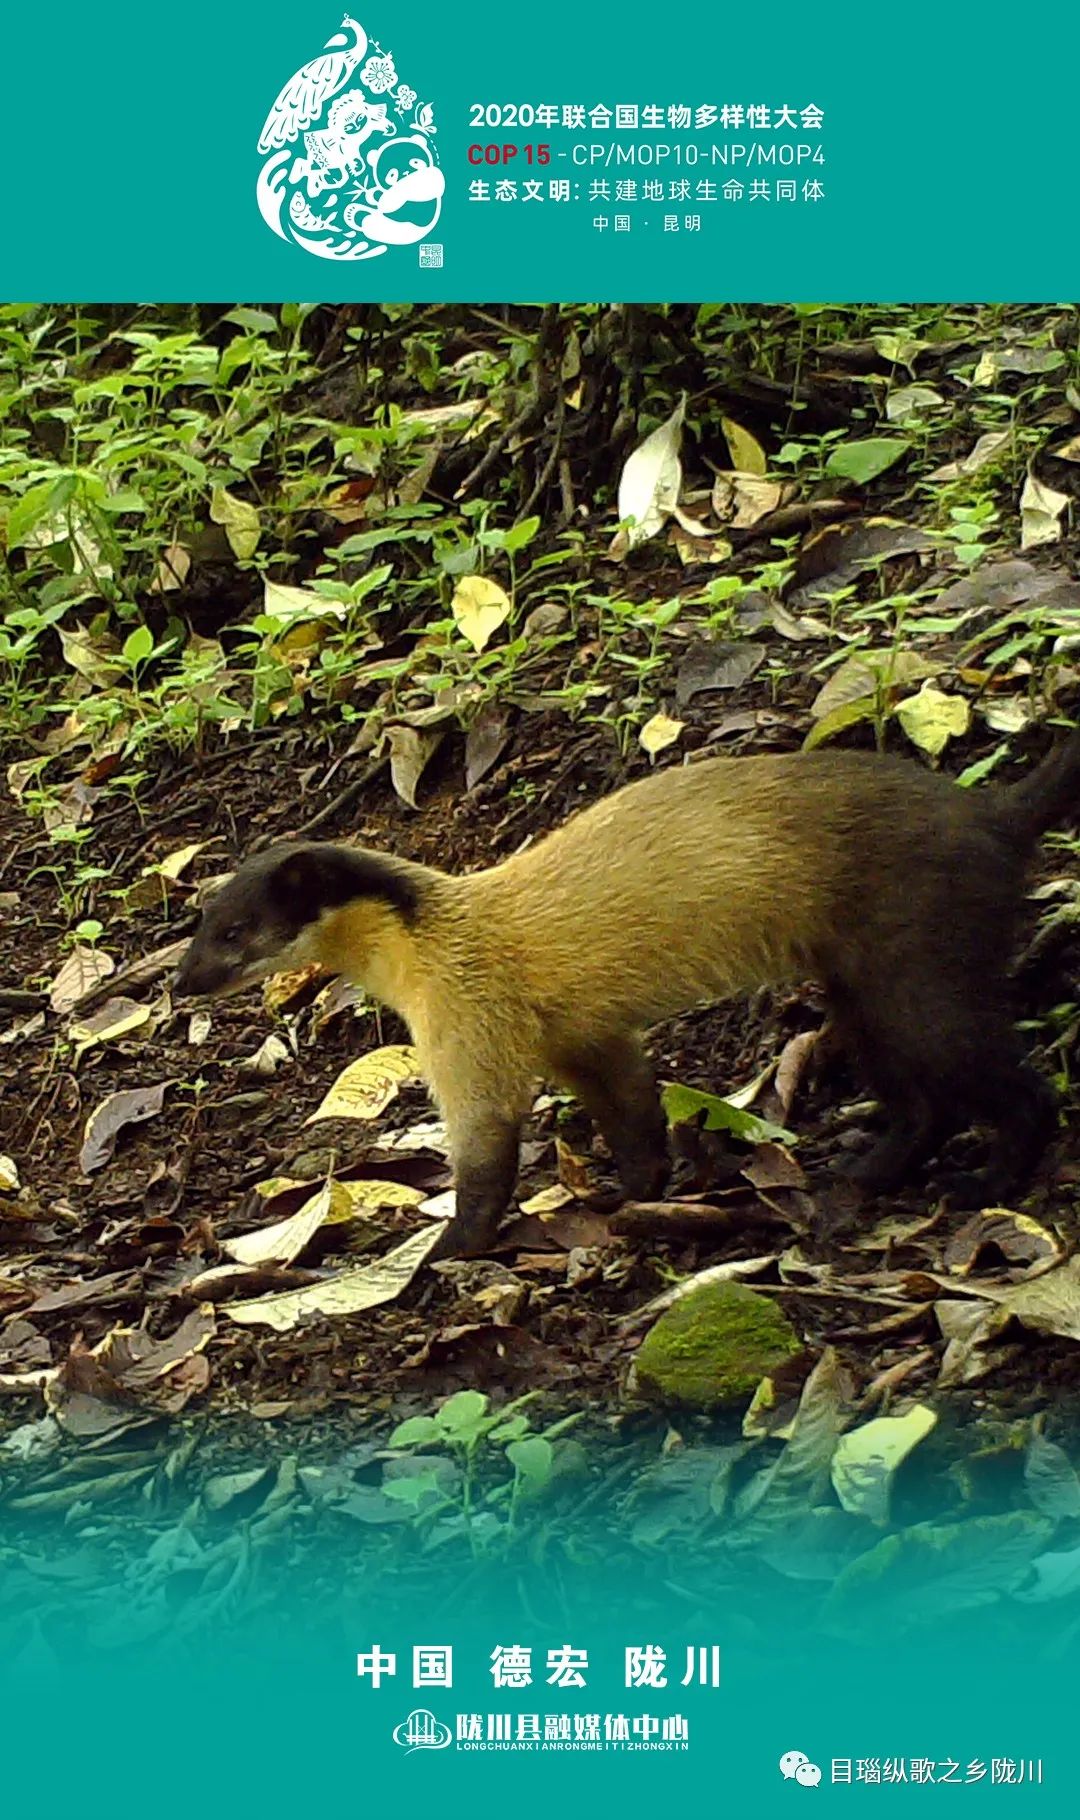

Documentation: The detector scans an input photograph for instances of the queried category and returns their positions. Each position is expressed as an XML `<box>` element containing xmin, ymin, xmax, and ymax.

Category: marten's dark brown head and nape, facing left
<box><xmin>177</xmin><ymin>841</ymin><xmax>424</xmax><ymax>997</ymax></box>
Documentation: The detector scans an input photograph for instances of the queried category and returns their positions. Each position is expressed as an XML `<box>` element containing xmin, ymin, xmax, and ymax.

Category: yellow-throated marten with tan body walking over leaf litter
<box><xmin>178</xmin><ymin>732</ymin><xmax>1080</xmax><ymax>1254</ymax></box>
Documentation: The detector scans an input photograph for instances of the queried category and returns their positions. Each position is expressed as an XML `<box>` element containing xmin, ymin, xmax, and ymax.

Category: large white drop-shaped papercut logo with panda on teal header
<box><xmin>259</xmin><ymin>13</ymin><xmax>446</xmax><ymax>260</ymax></box>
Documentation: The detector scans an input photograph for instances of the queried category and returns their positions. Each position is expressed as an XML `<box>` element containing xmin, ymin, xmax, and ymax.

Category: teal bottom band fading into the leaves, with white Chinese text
<box><xmin>0</xmin><ymin>1502</ymin><xmax>1076</xmax><ymax>1816</ymax></box>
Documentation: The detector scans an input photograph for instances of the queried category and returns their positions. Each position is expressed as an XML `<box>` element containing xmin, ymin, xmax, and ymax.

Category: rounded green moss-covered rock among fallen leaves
<box><xmin>634</xmin><ymin>1283</ymin><xmax>801</xmax><ymax>1409</ymax></box>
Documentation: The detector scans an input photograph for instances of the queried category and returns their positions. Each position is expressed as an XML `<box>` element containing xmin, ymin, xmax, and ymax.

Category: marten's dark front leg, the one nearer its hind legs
<box><xmin>555</xmin><ymin>1037</ymin><xmax>670</xmax><ymax>1201</ymax></box>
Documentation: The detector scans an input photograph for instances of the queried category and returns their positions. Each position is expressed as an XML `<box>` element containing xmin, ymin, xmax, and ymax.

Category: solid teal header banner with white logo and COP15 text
<box><xmin>5</xmin><ymin>0</ymin><xmax>1080</xmax><ymax>302</ymax></box>
